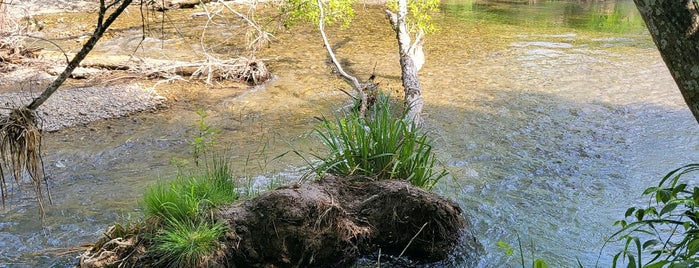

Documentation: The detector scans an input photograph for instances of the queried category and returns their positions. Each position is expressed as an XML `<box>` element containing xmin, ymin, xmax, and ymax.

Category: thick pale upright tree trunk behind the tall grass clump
<box><xmin>386</xmin><ymin>0</ymin><xmax>424</xmax><ymax>124</ymax></box>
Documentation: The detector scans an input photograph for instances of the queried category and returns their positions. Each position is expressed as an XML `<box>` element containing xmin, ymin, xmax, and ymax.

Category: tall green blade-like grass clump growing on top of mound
<box><xmin>315</xmin><ymin>94</ymin><xmax>447</xmax><ymax>189</ymax></box>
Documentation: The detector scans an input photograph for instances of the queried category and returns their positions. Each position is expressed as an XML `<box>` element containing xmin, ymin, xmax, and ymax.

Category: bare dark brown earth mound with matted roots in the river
<box><xmin>221</xmin><ymin>177</ymin><xmax>475</xmax><ymax>267</ymax></box>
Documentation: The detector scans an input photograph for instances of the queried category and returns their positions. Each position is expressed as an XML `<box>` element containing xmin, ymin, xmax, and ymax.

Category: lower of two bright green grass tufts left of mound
<box><xmin>150</xmin><ymin>219</ymin><xmax>227</xmax><ymax>267</ymax></box>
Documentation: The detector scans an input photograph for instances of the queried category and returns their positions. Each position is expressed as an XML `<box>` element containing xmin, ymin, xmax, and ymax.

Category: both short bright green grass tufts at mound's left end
<box><xmin>143</xmin><ymin>157</ymin><xmax>238</xmax><ymax>267</ymax></box>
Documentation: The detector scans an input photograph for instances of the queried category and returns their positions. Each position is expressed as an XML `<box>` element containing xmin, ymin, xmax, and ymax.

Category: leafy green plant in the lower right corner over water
<box><xmin>612</xmin><ymin>164</ymin><xmax>699</xmax><ymax>267</ymax></box>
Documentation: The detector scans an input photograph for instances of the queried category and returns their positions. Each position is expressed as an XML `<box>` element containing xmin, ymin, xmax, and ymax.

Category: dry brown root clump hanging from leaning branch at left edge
<box><xmin>0</xmin><ymin>108</ymin><xmax>51</xmax><ymax>214</ymax></box>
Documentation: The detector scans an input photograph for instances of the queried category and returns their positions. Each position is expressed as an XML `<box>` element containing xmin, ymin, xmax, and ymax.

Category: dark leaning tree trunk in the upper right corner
<box><xmin>634</xmin><ymin>0</ymin><xmax>699</xmax><ymax>122</ymax></box>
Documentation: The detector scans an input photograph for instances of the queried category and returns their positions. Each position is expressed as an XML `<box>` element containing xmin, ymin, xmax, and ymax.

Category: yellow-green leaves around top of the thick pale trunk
<box><xmin>386</xmin><ymin>0</ymin><xmax>439</xmax><ymax>33</ymax></box>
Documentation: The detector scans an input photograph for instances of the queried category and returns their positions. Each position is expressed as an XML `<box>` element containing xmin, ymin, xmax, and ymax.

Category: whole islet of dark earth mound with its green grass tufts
<box><xmin>80</xmin><ymin>91</ymin><xmax>475</xmax><ymax>267</ymax></box>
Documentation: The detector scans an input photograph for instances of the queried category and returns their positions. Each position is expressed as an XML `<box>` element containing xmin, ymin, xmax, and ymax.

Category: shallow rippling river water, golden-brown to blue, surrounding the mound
<box><xmin>0</xmin><ymin>0</ymin><xmax>699</xmax><ymax>267</ymax></box>
